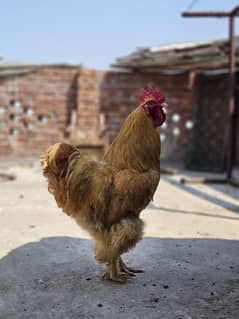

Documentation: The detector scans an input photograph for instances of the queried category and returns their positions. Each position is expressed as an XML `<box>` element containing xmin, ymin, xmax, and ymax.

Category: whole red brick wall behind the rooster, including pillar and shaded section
<box><xmin>0</xmin><ymin>68</ymin><xmax>192</xmax><ymax>160</ymax></box>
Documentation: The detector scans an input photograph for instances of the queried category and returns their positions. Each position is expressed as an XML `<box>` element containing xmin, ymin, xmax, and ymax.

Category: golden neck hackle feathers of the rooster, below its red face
<box><xmin>104</xmin><ymin>105</ymin><xmax>160</xmax><ymax>172</ymax></box>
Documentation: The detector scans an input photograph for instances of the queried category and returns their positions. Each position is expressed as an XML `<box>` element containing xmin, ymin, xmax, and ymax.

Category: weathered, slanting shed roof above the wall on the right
<box><xmin>113</xmin><ymin>38</ymin><xmax>239</xmax><ymax>71</ymax></box>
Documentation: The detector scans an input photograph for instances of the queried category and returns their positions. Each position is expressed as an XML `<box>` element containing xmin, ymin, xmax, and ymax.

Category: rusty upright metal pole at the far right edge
<box><xmin>226</xmin><ymin>15</ymin><xmax>236</xmax><ymax>181</ymax></box>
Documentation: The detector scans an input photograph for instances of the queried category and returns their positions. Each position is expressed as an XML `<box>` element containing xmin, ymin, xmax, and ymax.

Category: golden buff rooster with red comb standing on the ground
<box><xmin>41</xmin><ymin>88</ymin><xmax>167</xmax><ymax>282</ymax></box>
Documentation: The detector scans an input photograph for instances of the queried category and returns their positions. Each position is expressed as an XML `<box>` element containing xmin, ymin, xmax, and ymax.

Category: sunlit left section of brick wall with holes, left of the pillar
<box><xmin>0</xmin><ymin>68</ymin><xmax>79</xmax><ymax>156</ymax></box>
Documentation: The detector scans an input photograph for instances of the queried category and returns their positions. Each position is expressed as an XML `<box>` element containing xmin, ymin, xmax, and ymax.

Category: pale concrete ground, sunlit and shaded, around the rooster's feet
<box><xmin>0</xmin><ymin>163</ymin><xmax>239</xmax><ymax>319</ymax></box>
